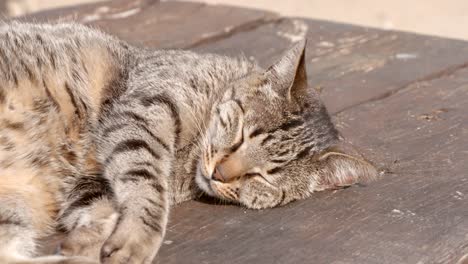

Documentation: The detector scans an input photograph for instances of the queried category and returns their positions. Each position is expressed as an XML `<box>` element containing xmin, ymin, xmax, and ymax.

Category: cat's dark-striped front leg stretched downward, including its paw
<box><xmin>99</xmin><ymin>95</ymin><xmax>178</xmax><ymax>264</ymax></box>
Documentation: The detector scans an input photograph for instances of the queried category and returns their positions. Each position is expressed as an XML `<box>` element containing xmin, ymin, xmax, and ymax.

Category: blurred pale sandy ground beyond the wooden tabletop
<box><xmin>0</xmin><ymin>0</ymin><xmax>468</xmax><ymax>40</ymax></box>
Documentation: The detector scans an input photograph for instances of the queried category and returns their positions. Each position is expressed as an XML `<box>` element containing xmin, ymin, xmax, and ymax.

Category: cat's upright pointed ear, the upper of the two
<box><xmin>266</xmin><ymin>39</ymin><xmax>307</xmax><ymax>100</ymax></box>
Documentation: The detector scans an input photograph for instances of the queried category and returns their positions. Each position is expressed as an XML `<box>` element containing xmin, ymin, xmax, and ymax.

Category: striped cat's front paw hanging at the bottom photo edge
<box><xmin>101</xmin><ymin>219</ymin><xmax>162</xmax><ymax>264</ymax></box>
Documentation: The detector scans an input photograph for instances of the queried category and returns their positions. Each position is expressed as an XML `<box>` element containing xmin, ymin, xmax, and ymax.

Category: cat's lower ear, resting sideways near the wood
<box><xmin>317</xmin><ymin>148</ymin><xmax>378</xmax><ymax>189</ymax></box>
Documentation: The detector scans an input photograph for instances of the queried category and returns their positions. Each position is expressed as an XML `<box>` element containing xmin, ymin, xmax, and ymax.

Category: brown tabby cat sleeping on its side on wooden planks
<box><xmin>0</xmin><ymin>22</ymin><xmax>376</xmax><ymax>263</ymax></box>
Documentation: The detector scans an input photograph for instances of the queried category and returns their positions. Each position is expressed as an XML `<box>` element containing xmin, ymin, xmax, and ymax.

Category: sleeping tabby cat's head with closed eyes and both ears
<box><xmin>196</xmin><ymin>41</ymin><xmax>377</xmax><ymax>209</ymax></box>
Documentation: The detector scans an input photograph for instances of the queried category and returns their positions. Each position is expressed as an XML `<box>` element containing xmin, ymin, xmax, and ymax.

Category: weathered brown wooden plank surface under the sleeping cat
<box><xmin>22</xmin><ymin>0</ymin><xmax>468</xmax><ymax>263</ymax></box>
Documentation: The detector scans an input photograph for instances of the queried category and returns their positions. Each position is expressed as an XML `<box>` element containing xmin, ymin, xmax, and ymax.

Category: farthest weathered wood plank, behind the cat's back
<box><xmin>21</xmin><ymin>0</ymin><xmax>279</xmax><ymax>49</ymax></box>
